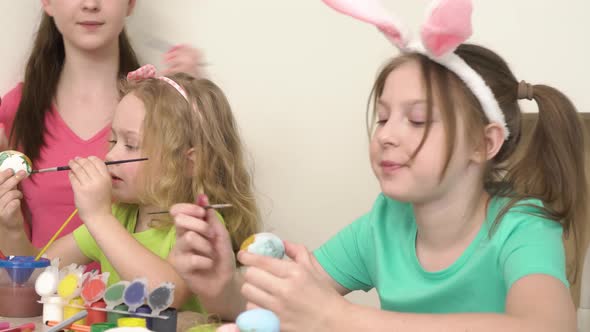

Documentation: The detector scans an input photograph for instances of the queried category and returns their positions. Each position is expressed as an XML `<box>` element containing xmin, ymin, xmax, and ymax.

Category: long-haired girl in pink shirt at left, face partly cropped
<box><xmin>0</xmin><ymin>0</ymin><xmax>204</xmax><ymax>255</ymax></box>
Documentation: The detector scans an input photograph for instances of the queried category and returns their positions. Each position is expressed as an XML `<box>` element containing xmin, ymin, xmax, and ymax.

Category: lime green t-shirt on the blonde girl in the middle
<box><xmin>73</xmin><ymin>204</ymin><xmax>204</xmax><ymax>313</ymax></box>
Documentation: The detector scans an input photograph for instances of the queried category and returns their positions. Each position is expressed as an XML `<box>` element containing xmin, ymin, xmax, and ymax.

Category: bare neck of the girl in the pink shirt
<box><xmin>58</xmin><ymin>41</ymin><xmax>119</xmax><ymax>97</ymax></box>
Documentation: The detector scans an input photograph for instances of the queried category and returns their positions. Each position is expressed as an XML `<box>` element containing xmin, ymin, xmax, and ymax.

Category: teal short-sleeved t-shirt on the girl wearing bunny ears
<box><xmin>314</xmin><ymin>194</ymin><xmax>569</xmax><ymax>313</ymax></box>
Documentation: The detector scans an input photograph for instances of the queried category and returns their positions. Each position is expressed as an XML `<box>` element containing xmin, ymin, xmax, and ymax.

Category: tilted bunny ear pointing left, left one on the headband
<box><xmin>323</xmin><ymin>0</ymin><xmax>404</xmax><ymax>48</ymax></box>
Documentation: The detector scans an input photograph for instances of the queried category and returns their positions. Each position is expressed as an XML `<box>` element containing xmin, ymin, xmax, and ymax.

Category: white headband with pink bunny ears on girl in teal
<box><xmin>323</xmin><ymin>0</ymin><xmax>510</xmax><ymax>139</ymax></box>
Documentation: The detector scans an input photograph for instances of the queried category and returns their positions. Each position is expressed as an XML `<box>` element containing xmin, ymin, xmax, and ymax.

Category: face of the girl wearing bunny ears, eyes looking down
<box><xmin>370</xmin><ymin>61</ymin><xmax>478</xmax><ymax>203</ymax></box>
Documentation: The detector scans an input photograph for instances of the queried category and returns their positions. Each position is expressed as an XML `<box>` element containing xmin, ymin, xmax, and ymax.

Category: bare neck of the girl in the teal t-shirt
<box><xmin>414</xmin><ymin>174</ymin><xmax>490</xmax><ymax>250</ymax></box>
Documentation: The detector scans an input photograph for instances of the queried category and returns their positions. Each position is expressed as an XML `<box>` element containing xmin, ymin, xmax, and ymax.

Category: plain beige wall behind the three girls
<box><xmin>0</xmin><ymin>0</ymin><xmax>590</xmax><ymax>304</ymax></box>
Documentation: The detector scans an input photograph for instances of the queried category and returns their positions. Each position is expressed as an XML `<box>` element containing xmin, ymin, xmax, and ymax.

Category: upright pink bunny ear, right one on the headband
<box><xmin>422</xmin><ymin>0</ymin><xmax>473</xmax><ymax>57</ymax></box>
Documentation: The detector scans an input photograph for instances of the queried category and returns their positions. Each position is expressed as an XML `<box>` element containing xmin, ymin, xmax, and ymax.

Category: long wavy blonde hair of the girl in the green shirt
<box><xmin>122</xmin><ymin>74</ymin><xmax>259</xmax><ymax>251</ymax></box>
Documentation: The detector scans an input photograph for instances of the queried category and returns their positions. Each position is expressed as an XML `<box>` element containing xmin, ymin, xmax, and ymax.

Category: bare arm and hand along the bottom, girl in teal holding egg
<box><xmin>239</xmin><ymin>242</ymin><xmax>576</xmax><ymax>332</ymax></box>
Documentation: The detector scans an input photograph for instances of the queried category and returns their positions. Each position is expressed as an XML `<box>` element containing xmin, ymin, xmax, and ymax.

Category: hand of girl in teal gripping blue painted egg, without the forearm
<box><xmin>238</xmin><ymin>241</ymin><xmax>346</xmax><ymax>331</ymax></box>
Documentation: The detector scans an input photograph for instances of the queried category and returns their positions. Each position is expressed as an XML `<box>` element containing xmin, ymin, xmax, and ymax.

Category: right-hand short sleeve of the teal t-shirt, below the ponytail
<box><xmin>500</xmin><ymin>212</ymin><xmax>569</xmax><ymax>289</ymax></box>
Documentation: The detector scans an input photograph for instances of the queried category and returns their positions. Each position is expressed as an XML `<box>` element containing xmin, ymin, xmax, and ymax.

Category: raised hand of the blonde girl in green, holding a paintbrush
<box><xmin>68</xmin><ymin>156</ymin><xmax>112</xmax><ymax>222</ymax></box>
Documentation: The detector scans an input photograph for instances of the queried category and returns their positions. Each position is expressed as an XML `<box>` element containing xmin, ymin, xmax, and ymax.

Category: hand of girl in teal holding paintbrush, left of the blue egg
<box><xmin>170</xmin><ymin>195</ymin><xmax>237</xmax><ymax>299</ymax></box>
